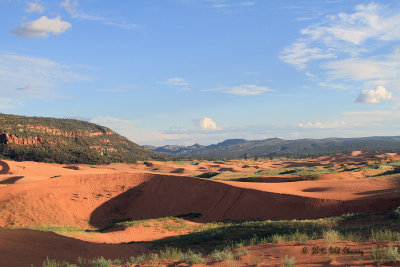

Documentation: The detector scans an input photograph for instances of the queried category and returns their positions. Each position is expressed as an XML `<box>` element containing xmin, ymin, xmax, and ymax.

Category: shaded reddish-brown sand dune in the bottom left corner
<box><xmin>0</xmin><ymin>230</ymin><xmax>146</xmax><ymax>267</ymax></box>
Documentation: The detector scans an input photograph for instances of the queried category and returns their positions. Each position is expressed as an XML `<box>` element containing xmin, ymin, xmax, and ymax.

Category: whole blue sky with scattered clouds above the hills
<box><xmin>0</xmin><ymin>0</ymin><xmax>400</xmax><ymax>146</ymax></box>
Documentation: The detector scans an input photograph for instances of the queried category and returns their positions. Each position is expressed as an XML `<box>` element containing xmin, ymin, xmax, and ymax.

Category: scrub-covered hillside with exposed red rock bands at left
<box><xmin>0</xmin><ymin>114</ymin><xmax>165</xmax><ymax>164</ymax></box>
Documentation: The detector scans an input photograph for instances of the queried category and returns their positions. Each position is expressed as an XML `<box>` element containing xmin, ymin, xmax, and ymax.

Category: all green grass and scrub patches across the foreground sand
<box><xmin>24</xmin><ymin>208</ymin><xmax>400</xmax><ymax>266</ymax></box>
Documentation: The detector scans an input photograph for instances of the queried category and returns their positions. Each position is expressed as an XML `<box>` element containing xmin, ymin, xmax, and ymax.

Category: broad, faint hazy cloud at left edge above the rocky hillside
<box><xmin>0</xmin><ymin>53</ymin><xmax>92</xmax><ymax>99</ymax></box>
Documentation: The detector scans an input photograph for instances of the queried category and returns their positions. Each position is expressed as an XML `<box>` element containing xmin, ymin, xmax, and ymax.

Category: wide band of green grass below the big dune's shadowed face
<box><xmin>138</xmin><ymin>211</ymin><xmax>400</xmax><ymax>253</ymax></box>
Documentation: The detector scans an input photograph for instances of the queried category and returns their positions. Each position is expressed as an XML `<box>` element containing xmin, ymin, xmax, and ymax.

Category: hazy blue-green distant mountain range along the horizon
<box><xmin>146</xmin><ymin>136</ymin><xmax>400</xmax><ymax>159</ymax></box>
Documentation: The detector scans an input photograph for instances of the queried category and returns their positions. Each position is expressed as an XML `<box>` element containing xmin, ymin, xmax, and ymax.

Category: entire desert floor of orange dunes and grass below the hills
<box><xmin>0</xmin><ymin>151</ymin><xmax>400</xmax><ymax>266</ymax></box>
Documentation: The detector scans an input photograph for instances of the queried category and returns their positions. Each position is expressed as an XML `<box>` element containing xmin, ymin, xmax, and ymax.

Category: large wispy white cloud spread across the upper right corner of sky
<box><xmin>280</xmin><ymin>3</ymin><xmax>400</xmax><ymax>69</ymax></box>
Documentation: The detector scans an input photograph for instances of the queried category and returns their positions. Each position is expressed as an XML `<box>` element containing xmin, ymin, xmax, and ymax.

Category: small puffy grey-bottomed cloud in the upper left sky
<box><xmin>11</xmin><ymin>16</ymin><xmax>71</xmax><ymax>39</ymax></box>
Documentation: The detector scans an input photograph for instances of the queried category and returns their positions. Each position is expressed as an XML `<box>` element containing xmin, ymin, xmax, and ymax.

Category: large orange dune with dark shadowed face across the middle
<box><xmin>0</xmin><ymin>173</ymin><xmax>400</xmax><ymax>227</ymax></box>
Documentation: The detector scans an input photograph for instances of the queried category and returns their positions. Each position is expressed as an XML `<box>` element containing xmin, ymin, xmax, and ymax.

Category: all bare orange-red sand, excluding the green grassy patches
<box><xmin>0</xmin><ymin>152</ymin><xmax>400</xmax><ymax>266</ymax></box>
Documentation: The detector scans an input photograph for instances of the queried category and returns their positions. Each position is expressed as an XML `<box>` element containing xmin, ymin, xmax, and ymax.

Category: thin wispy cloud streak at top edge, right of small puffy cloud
<box><xmin>61</xmin><ymin>0</ymin><xmax>140</xmax><ymax>30</ymax></box>
